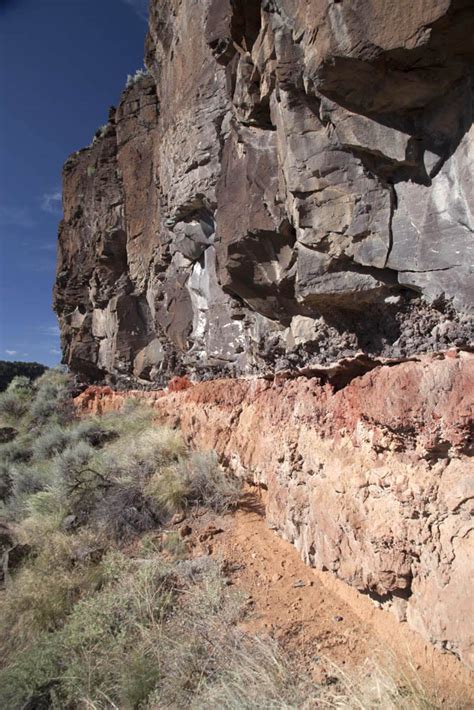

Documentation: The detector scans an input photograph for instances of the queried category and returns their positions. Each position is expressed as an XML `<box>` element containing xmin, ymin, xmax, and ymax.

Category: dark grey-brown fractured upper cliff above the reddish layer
<box><xmin>55</xmin><ymin>0</ymin><xmax>474</xmax><ymax>384</ymax></box>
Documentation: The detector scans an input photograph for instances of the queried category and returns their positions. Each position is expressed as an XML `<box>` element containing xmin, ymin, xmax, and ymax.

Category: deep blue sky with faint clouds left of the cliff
<box><xmin>0</xmin><ymin>0</ymin><xmax>148</xmax><ymax>365</ymax></box>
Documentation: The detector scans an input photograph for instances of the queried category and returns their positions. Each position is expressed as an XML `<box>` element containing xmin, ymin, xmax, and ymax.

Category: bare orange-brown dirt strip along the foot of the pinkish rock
<box><xmin>182</xmin><ymin>495</ymin><xmax>474</xmax><ymax>708</ymax></box>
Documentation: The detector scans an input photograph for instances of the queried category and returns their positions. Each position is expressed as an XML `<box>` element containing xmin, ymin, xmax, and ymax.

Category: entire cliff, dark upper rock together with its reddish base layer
<box><xmin>55</xmin><ymin>0</ymin><xmax>474</xmax><ymax>665</ymax></box>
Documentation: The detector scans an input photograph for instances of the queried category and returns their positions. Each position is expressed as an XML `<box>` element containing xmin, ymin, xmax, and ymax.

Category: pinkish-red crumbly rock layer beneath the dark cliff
<box><xmin>76</xmin><ymin>351</ymin><xmax>474</xmax><ymax>667</ymax></box>
